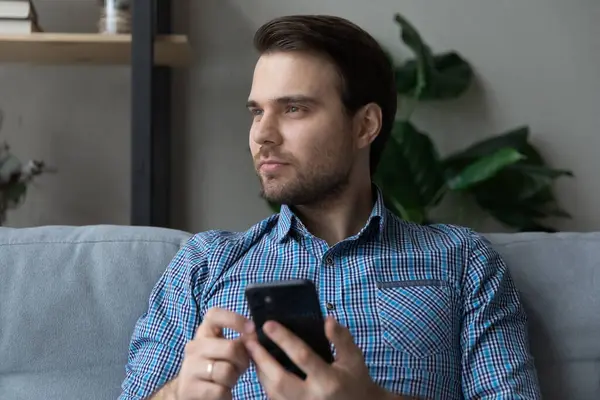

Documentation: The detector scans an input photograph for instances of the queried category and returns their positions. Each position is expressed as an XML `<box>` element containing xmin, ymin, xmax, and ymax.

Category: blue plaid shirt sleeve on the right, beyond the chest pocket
<box><xmin>461</xmin><ymin>232</ymin><xmax>541</xmax><ymax>400</ymax></box>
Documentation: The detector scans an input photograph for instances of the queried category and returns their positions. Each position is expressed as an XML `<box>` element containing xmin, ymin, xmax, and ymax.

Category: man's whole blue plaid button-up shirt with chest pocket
<box><xmin>120</xmin><ymin>194</ymin><xmax>540</xmax><ymax>400</ymax></box>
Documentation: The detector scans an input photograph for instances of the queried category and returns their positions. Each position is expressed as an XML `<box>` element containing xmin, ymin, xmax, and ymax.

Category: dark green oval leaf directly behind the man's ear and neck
<box><xmin>374</xmin><ymin>121</ymin><xmax>445</xmax><ymax>222</ymax></box>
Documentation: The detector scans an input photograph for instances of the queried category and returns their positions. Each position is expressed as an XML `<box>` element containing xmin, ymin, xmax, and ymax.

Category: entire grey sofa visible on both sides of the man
<box><xmin>0</xmin><ymin>226</ymin><xmax>600</xmax><ymax>400</ymax></box>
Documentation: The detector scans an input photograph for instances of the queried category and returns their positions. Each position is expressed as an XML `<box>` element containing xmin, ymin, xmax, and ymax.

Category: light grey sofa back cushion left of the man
<box><xmin>0</xmin><ymin>226</ymin><xmax>189</xmax><ymax>400</ymax></box>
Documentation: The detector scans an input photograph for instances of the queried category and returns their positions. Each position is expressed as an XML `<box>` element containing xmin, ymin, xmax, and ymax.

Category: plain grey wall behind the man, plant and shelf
<box><xmin>0</xmin><ymin>0</ymin><xmax>600</xmax><ymax>231</ymax></box>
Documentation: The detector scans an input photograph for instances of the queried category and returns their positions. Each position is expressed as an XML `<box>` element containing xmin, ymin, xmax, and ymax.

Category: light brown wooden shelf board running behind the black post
<box><xmin>0</xmin><ymin>33</ymin><xmax>191</xmax><ymax>67</ymax></box>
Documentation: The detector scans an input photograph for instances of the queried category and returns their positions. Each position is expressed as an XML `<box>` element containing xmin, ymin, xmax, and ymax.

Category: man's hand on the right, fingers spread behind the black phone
<box><xmin>245</xmin><ymin>318</ymin><xmax>390</xmax><ymax>400</ymax></box>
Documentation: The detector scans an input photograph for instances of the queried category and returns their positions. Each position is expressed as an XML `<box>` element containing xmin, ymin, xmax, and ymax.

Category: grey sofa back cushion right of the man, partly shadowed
<box><xmin>487</xmin><ymin>232</ymin><xmax>600</xmax><ymax>400</ymax></box>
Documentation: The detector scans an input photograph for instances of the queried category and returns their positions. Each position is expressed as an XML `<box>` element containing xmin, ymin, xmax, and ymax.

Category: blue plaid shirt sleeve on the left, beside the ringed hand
<box><xmin>119</xmin><ymin>235</ymin><xmax>208</xmax><ymax>400</ymax></box>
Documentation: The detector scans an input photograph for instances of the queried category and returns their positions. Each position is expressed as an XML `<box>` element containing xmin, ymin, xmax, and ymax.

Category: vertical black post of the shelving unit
<box><xmin>131</xmin><ymin>0</ymin><xmax>172</xmax><ymax>227</ymax></box>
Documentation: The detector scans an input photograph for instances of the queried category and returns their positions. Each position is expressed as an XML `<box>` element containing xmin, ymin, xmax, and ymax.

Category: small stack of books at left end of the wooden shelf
<box><xmin>0</xmin><ymin>0</ymin><xmax>42</xmax><ymax>35</ymax></box>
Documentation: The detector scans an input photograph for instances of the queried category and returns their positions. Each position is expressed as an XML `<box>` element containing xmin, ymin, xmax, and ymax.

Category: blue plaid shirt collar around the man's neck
<box><xmin>277</xmin><ymin>185</ymin><xmax>387</xmax><ymax>242</ymax></box>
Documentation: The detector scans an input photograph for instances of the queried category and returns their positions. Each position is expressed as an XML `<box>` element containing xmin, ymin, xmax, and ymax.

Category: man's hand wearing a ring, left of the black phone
<box><xmin>175</xmin><ymin>308</ymin><xmax>250</xmax><ymax>400</ymax></box>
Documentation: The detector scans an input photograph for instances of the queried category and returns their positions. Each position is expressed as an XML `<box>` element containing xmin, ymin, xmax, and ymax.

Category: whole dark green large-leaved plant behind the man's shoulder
<box><xmin>374</xmin><ymin>14</ymin><xmax>572</xmax><ymax>232</ymax></box>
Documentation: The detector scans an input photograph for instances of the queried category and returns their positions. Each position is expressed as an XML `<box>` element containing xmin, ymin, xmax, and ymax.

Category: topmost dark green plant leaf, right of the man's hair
<box><xmin>395</xmin><ymin>14</ymin><xmax>474</xmax><ymax>100</ymax></box>
